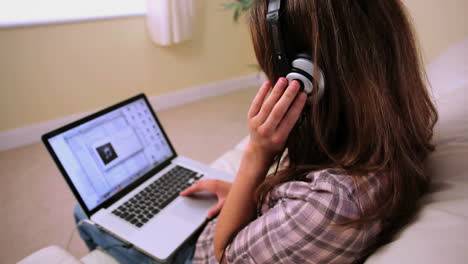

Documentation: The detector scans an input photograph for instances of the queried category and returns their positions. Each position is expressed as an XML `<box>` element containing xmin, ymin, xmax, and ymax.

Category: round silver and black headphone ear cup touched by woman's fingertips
<box><xmin>286</xmin><ymin>55</ymin><xmax>325</xmax><ymax>99</ymax></box>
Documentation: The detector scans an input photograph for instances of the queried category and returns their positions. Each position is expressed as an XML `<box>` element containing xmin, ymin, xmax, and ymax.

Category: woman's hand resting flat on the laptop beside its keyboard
<box><xmin>180</xmin><ymin>180</ymin><xmax>231</xmax><ymax>219</ymax></box>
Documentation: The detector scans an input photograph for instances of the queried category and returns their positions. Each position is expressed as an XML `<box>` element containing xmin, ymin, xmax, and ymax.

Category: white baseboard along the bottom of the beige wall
<box><xmin>0</xmin><ymin>74</ymin><xmax>265</xmax><ymax>151</ymax></box>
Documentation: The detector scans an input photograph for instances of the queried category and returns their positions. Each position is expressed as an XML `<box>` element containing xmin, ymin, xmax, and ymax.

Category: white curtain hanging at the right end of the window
<box><xmin>146</xmin><ymin>0</ymin><xmax>194</xmax><ymax>46</ymax></box>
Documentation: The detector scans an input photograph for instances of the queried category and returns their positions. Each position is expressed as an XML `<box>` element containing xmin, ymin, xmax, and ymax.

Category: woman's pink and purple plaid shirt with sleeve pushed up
<box><xmin>193</xmin><ymin>169</ymin><xmax>382</xmax><ymax>264</ymax></box>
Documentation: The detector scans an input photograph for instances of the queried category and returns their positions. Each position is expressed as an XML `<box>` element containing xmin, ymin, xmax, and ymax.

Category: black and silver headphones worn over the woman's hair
<box><xmin>266</xmin><ymin>0</ymin><xmax>325</xmax><ymax>99</ymax></box>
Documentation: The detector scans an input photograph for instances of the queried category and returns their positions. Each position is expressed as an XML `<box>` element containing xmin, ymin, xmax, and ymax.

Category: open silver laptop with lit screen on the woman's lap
<box><xmin>42</xmin><ymin>94</ymin><xmax>233</xmax><ymax>261</ymax></box>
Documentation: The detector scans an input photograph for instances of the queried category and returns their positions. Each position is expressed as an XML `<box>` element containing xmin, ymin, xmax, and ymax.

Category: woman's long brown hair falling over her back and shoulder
<box><xmin>249</xmin><ymin>0</ymin><xmax>437</xmax><ymax>243</ymax></box>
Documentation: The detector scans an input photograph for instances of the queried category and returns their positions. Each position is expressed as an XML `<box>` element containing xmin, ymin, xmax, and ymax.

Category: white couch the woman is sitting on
<box><xmin>19</xmin><ymin>38</ymin><xmax>468</xmax><ymax>264</ymax></box>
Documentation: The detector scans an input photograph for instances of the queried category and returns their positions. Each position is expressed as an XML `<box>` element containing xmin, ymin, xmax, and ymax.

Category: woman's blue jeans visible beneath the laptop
<box><xmin>73</xmin><ymin>204</ymin><xmax>198</xmax><ymax>264</ymax></box>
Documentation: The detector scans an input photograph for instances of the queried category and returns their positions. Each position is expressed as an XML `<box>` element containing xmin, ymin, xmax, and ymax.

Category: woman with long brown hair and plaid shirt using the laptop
<box><xmin>74</xmin><ymin>0</ymin><xmax>437</xmax><ymax>263</ymax></box>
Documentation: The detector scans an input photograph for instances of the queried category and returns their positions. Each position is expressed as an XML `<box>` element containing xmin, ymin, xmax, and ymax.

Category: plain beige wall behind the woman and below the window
<box><xmin>0</xmin><ymin>0</ymin><xmax>468</xmax><ymax>131</ymax></box>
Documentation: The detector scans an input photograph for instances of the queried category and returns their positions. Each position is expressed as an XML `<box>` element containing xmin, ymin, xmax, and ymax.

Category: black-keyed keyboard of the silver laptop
<box><xmin>112</xmin><ymin>166</ymin><xmax>203</xmax><ymax>227</ymax></box>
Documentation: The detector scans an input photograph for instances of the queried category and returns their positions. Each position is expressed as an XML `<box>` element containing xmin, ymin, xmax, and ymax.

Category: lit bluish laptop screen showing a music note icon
<box><xmin>49</xmin><ymin>98</ymin><xmax>175</xmax><ymax>211</ymax></box>
